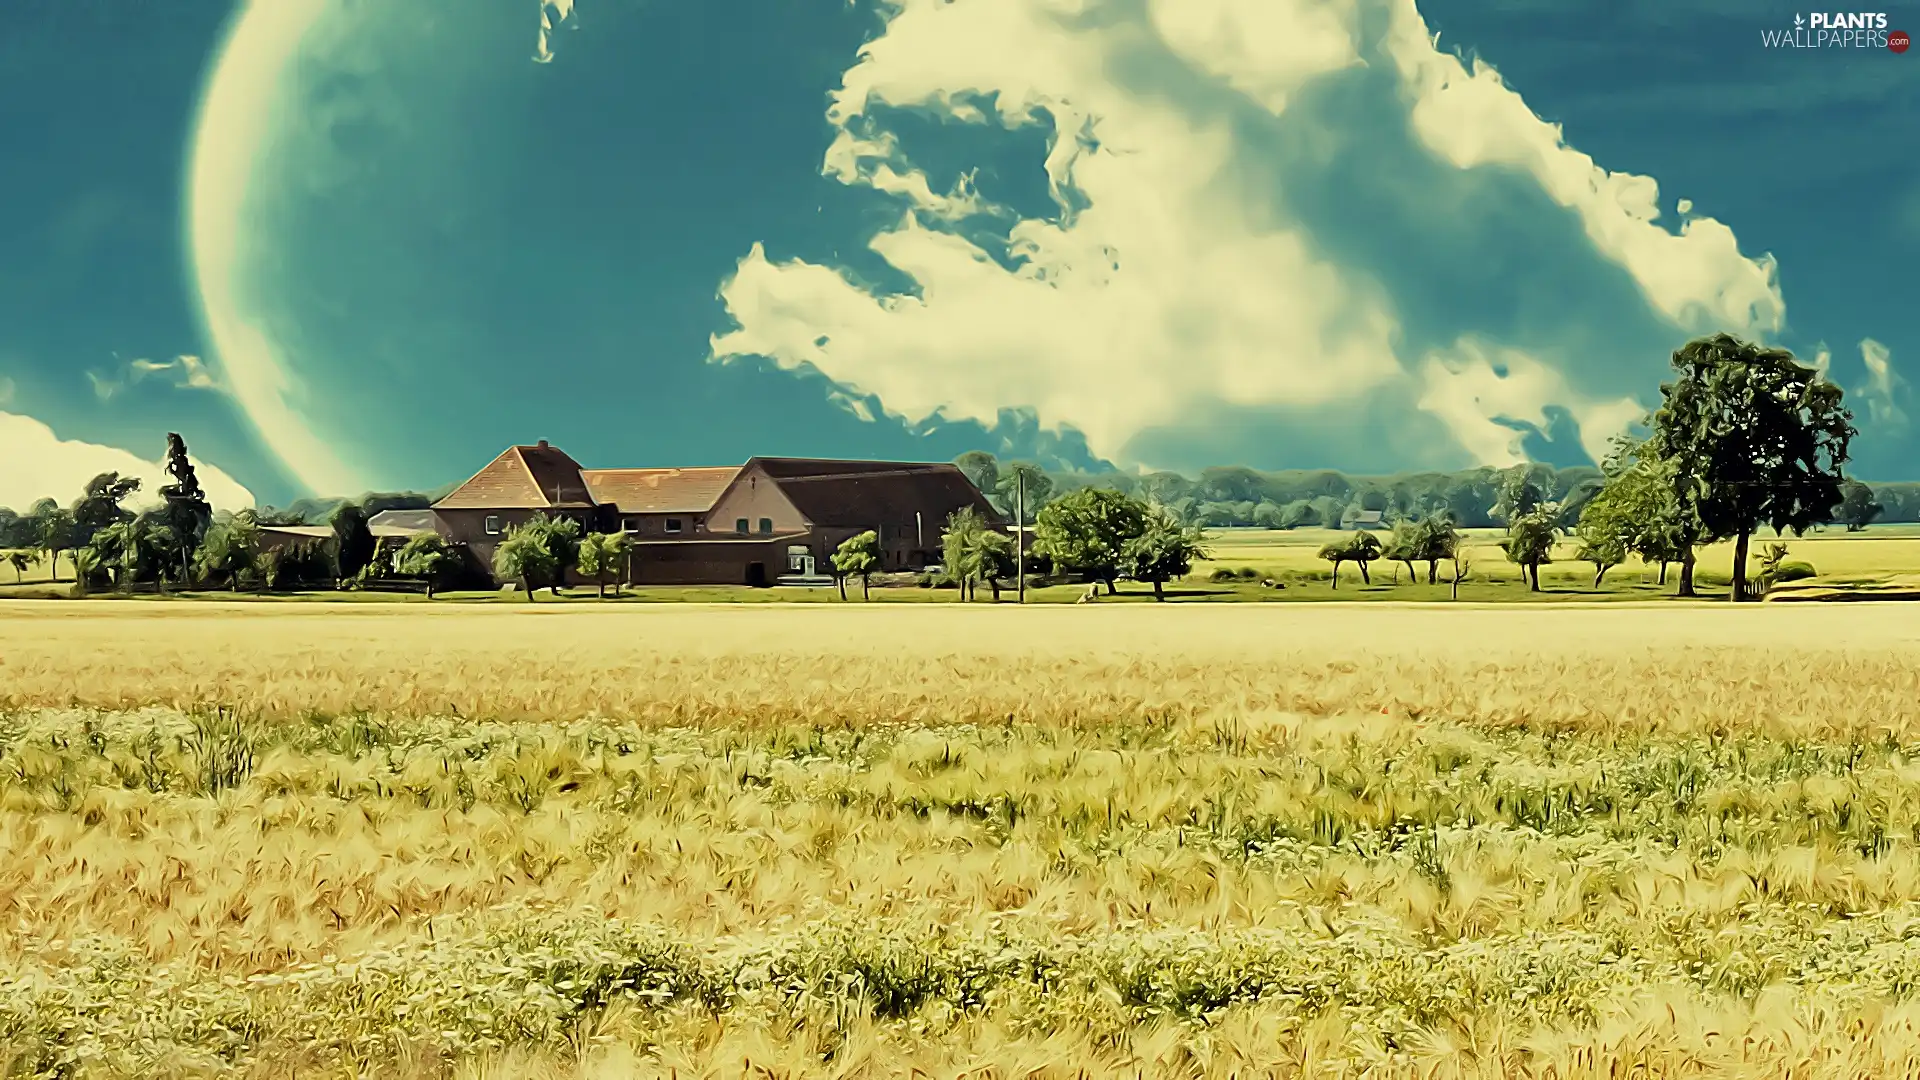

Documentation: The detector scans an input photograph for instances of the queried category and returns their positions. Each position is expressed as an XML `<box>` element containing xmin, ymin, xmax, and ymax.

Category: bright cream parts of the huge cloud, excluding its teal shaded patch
<box><xmin>712</xmin><ymin>0</ymin><xmax>1784</xmax><ymax>461</ymax></box>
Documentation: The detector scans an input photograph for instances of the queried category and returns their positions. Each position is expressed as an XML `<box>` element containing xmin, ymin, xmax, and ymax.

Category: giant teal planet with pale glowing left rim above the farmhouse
<box><xmin>186</xmin><ymin>0</ymin><xmax>944</xmax><ymax>492</ymax></box>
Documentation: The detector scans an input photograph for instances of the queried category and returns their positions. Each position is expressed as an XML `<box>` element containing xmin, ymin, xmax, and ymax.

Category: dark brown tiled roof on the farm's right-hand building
<box><xmin>749</xmin><ymin>457</ymin><xmax>1002</xmax><ymax>530</ymax></box>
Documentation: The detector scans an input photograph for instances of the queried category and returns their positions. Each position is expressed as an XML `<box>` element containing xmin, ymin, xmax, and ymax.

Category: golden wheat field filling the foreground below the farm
<box><xmin>0</xmin><ymin>603</ymin><xmax>1920</xmax><ymax>1078</ymax></box>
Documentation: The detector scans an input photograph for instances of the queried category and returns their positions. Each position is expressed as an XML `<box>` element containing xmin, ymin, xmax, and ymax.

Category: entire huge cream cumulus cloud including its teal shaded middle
<box><xmin>712</xmin><ymin>0</ymin><xmax>1784</xmax><ymax>465</ymax></box>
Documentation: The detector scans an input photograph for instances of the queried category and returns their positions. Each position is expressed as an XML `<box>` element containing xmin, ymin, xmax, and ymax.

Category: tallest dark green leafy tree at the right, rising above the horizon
<box><xmin>1649</xmin><ymin>334</ymin><xmax>1857</xmax><ymax>601</ymax></box>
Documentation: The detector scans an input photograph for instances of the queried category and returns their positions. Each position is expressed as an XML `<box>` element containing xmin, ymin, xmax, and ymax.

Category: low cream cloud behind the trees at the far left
<box><xmin>0</xmin><ymin>413</ymin><xmax>253</xmax><ymax>513</ymax></box>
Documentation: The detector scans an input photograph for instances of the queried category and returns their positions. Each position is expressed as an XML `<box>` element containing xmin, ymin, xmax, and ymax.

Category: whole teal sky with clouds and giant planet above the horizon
<box><xmin>0</xmin><ymin>0</ymin><xmax>1920</xmax><ymax>507</ymax></box>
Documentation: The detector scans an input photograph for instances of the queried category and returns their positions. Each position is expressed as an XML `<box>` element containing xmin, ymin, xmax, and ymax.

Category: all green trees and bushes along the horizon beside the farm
<box><xmin>0</xmin><ymin>334</ymin><xmax>1896</xmax><ymax>594</ymax></box>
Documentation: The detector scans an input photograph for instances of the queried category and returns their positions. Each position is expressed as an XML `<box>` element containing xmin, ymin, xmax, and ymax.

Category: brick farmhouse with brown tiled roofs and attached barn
<box><xmin>428</xmin><ymin>440</ymin><xmax>1004</xmax><ymax>586</ymax></box>
